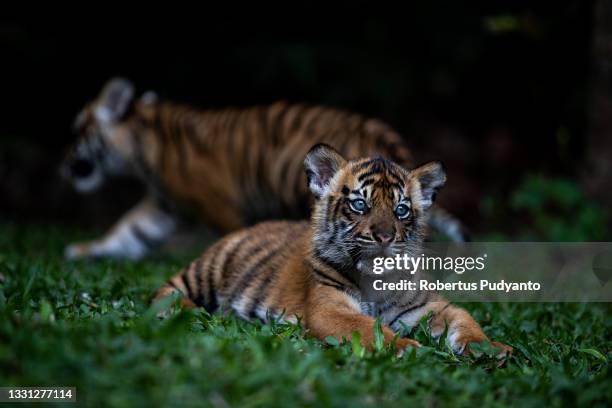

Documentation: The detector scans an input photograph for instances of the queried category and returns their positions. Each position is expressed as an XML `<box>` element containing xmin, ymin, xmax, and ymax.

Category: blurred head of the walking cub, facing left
<box><xmin>60</xmin><ymin>78</ymin><xmax>154</xmax><ymax>192</ymax></box>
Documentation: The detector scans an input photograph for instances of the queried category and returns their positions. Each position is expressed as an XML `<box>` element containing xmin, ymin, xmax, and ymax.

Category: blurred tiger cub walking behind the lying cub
<box><xmin>63</xmin><ymin>79</ymin><xmax>463</xmax><ymax>259</ymax></box>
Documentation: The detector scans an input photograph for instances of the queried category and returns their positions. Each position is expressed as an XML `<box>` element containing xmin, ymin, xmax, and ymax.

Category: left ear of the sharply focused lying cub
<box><xmin>304</xmin><ymin>143</ymin><xmax>346</xmax><ymax>199</ymax></box>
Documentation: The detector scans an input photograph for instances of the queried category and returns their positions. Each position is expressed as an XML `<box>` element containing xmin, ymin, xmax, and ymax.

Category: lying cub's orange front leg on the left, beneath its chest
<box><xmin>305</xmin><ymin>285</ymin><xmax>420</xmax><ymax>351</ymax></box>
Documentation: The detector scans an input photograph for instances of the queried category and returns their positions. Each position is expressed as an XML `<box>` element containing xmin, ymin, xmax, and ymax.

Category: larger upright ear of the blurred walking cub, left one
<box><xmin>95</xmin><ymin>78</ymin><xmax>134</xmax><ymax>123</ymax></box>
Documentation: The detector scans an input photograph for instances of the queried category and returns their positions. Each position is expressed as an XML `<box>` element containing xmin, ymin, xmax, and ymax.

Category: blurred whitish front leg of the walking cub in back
<box><xmin>65</xmin><ymin>197</ymin><xmax>176</xmax><ymax>259</ymax></box>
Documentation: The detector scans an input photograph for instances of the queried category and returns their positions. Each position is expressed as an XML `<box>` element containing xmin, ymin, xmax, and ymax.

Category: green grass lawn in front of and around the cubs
<box><xmin>0</xmin><ymin>224</ymin><xmax>612</xmax><ymax>408</ymax></box>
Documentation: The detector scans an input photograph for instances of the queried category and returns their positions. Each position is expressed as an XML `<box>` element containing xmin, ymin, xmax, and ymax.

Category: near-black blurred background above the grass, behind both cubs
<box><xmin>0</xmin><ymin>0</ymin><xmax>612</xmax><ymax>238</ymax></box>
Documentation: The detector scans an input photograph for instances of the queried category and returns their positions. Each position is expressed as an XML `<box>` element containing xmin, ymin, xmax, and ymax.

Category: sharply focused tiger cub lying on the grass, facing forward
<box><xmin>155</xmin><ymin>144</ymin><xmax>511</xmax><ymax>353</ymax></box>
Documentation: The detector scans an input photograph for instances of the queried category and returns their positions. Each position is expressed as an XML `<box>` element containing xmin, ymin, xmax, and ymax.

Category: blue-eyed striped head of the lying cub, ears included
<box><xmin>305</xmin><ymin>145</ymin><xmax>446</xmax><ymax>274</ymax></box>
